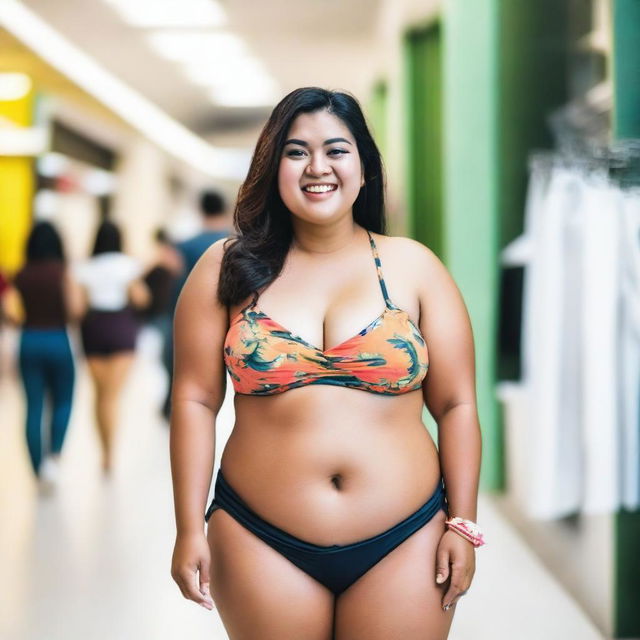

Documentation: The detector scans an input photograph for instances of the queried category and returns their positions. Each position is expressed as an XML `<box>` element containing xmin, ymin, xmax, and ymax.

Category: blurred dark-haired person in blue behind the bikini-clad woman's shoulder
<box><xmin>162</xmin><ymin>189</ymin><xmax>231</xmax><ymax>419</ymax></box>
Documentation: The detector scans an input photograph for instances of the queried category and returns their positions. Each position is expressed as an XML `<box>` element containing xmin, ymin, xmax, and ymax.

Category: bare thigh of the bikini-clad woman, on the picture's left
<box><xmin>207</xmin><ymin>509</ymin><xmax>334</xmax><ymax>640</ymax></box>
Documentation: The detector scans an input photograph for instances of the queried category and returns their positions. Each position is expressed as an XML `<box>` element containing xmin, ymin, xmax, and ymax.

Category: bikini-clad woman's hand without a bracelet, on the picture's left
<box><xmin>171</xmin><ymin>532</ymin><xmax>214</xmax><ymax>610</ymax></box>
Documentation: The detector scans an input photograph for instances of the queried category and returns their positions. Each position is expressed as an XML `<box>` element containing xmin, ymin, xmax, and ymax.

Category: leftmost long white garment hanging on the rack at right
<box><xmin>522</xmin><ymin>167</ymin><xmax>583</xmax><ymax>519</ymax></box>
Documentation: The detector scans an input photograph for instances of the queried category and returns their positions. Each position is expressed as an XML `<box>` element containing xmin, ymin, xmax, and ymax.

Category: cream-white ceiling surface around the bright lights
<box><xmin>23</xmin><ymin>0</ymin><xmax>380</xmax><ymax>141</ymax></box>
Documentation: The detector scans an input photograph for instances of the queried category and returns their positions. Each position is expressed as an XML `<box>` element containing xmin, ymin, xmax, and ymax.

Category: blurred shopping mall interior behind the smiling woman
<box><xmin>0</xmin><ymin>0</ymin><xmax>640</xmax><ymax>640</ymax></box>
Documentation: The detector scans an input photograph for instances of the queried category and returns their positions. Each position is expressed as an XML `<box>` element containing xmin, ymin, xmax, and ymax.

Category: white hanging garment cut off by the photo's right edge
<box><xmin>618</xmin><ymin>190</ymin><xmax>640</xmax><ymax>511</ymax></box>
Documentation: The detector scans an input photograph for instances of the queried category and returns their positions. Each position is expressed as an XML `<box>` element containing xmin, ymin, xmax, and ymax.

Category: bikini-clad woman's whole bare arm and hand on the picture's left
<box><xmin>170</xmin><ymin>240</ymin><xmax>228</xmax><ymax>608</ymax></box>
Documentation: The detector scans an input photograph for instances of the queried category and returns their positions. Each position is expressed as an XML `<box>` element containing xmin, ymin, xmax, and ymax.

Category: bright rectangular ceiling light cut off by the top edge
<box><xmin>104</xmin><ymin>0</ymin><xmax>227</xmax><ymax>28</ymax></box>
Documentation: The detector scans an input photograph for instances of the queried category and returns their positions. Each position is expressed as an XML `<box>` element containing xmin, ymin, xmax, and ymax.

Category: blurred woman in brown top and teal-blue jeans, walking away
<box><xmin>6</xmin><ymin>222</ymin><xmax>82</xmax><ymax>492</ymax></box>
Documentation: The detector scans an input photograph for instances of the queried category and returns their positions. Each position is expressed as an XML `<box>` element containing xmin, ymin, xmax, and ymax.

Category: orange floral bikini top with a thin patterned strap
<box><xmin>224</xmin><ymin>231</ymin><xmax>429</xmax><ymax>395</ymax></box>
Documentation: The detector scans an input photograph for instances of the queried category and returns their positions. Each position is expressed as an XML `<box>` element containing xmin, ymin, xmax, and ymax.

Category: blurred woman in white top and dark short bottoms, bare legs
<box><xmin>76</xmin><ymin>221</ymin><xmax>149</xmax><ymax>475</ymax></box>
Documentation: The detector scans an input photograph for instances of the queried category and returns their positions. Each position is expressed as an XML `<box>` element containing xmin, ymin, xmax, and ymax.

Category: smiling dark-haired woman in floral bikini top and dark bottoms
<box><xmin>171</xmin><ymin>87</ymin><xmax>481</xmax><ymax>640</ymax></box>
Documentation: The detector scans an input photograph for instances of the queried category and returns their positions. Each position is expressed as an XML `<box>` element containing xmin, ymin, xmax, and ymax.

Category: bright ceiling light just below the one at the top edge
<box><xmin>147</xmin><ymin>31</ymin><xmax>247</xmax><ymax>63</ymax></box>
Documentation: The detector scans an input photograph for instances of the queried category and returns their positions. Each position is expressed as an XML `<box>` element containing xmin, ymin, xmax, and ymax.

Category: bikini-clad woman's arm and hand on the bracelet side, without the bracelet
<box><xmin>414</xmin><ymin>236</ymin><xmax>482</xmax><ymax>609</ymax></box>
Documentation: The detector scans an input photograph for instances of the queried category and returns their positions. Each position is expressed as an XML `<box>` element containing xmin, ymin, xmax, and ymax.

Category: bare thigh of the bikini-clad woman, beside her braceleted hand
<box><xmin>335</xmin><ymin>511</ymin><xmax>455</xmax><ymax>640</ymax></box>
